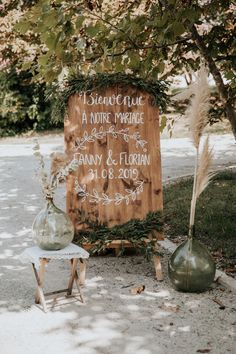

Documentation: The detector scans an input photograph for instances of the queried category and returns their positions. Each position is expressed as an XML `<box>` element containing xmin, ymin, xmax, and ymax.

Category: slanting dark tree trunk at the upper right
<box><xmin>189</xmin><ymin>25</ymin><xmax>236</xmax><ymax>139</ymax></box>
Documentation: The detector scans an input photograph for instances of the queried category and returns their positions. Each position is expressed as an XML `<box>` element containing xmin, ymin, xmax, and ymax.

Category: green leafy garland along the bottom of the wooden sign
<box><xmin>73</xmin><ymin>211</ymin><xmax>163</xmax><ymax>259</ymax></box>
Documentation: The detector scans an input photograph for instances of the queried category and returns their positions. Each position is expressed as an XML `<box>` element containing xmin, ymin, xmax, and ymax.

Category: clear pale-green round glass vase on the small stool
<box><xmin>32</xmin><ymin>199</ymin><xmax>74</xmax><ymax>251</ymax></box>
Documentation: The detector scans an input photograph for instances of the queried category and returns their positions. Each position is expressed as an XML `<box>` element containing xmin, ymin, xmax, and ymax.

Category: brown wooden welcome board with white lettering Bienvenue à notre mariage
<box><xmin>65</xmin><ymin>86</ymin><xmax>163</xmax><ymax>230</ymax></box>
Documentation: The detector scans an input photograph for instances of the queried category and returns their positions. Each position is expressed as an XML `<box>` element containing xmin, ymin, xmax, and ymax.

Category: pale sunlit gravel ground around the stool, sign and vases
<box><xmin>0</xmin><ymin>135</ymin><xmax>236</xmax><ymax>354</ymax></box>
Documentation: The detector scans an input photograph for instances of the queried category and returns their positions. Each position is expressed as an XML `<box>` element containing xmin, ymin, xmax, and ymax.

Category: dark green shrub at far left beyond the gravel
<box><xmin>0</xmin><ymin>68</ymin><xmax>63</xmax><ymax>136</ymax></box>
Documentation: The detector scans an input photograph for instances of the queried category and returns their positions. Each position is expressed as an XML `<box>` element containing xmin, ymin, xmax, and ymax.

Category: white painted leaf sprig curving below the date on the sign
<box><xmin>75</xmin><ymin>180</ymin><xmax>144</xmax><ymax>205</ymax></box>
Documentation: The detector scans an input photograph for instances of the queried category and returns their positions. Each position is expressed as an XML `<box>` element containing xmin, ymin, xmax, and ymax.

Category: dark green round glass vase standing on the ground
<box><xmin>168</xmin><ymin>231</ymin><xmax>216</xmax><ymax>292</ymax></box>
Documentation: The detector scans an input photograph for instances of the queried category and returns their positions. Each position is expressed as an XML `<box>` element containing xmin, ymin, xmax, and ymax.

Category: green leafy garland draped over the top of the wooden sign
<box><xmin>48</xmin><ymin>73</ymin><xmax>169</xmax><ymax>121</ymax></box>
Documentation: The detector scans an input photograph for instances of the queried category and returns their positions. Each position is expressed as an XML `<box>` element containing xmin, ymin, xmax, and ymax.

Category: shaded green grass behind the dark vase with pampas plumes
<box><xmin>164</xmin><ymin>170</ymin><xmax>236</xmax><ymax>272</ymax></box>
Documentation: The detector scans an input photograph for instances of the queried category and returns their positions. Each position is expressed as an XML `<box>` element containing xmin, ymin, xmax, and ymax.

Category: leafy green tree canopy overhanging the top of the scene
<box><xmin>0</xmin><ymin>0</ymin><xmax>236</xmax><ymax>135</ymax></box>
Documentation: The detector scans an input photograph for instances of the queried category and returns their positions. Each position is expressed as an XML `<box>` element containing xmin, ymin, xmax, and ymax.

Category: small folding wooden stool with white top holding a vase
<box><xmin>20</xmin><ymin>243</ymin><xmax>89</xmax><ymax>312</ymax></box>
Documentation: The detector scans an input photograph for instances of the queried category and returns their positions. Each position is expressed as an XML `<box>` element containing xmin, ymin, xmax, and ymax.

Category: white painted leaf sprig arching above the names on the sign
<box><xmin>75</xmin><ymin>126</ymin><xmax>147</xmax><ymax>152</ymax></box>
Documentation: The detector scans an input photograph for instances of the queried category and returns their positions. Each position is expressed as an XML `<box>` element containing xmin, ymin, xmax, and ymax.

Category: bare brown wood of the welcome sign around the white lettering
<box><xmin>65</xmin><ymin>86</ymin><xmax>163</xmax><ymax>228</ymax></box>
